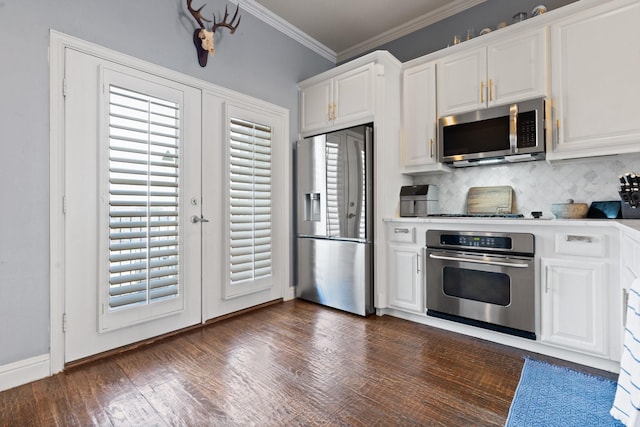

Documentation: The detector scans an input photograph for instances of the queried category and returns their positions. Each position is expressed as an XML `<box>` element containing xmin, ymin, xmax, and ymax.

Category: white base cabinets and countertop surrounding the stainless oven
<box><xmin>381</xmin><ymin>219</ymin><xmax>624</xmax><ymax>369</ymax></box>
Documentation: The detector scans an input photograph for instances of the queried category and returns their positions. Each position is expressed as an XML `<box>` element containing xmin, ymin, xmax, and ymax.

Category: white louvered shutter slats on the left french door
<box><xmin>108</xmin><ymin>85</ymin><xmax>180</xmax><ymax>310</ymax></box>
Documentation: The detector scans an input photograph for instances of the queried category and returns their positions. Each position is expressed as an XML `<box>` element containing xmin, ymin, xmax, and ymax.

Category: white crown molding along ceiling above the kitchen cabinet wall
<box><xmin>337</xmin><ymin>0</ymin><xmax>487</xmax><ymax>62</ymax></box>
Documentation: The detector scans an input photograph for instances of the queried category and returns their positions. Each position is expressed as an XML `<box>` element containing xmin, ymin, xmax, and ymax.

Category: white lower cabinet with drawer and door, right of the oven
<box><xmin>536</xmin><ymin>227</ymin><xmax>623</xmax><ymax>361</ymax></box>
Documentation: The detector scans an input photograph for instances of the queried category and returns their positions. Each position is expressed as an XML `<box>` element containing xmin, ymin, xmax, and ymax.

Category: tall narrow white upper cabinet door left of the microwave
<box><xmin>402</xmin><ymin>63</ymin><xmax>438</xmax><ymax>167</ymax></box>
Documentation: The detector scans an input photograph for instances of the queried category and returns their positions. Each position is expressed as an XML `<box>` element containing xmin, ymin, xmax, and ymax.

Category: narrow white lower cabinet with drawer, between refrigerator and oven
<box><xmin>387</xmin><ymin>223</ymin><xmax>425</xmax><ymax>314</ymax></box>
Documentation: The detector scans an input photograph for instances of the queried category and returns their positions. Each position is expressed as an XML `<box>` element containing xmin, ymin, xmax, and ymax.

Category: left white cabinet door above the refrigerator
<box><xmin>300</xmin><ymin>79</ymin><xmax>333</xmax><ymax>133</ymax></box>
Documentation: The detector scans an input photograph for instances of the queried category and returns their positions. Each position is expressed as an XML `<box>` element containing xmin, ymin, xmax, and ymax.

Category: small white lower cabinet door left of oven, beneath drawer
<box><xmin>389</xmin><ymin>245</ymin><xmax>424</xmax><ymax>314</ymax></box>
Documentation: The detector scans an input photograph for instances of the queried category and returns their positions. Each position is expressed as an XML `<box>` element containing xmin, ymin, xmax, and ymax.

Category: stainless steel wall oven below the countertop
<box><xmin>426</xmin><ymin>230</ymin><xmax>539</xmax><ymax>340</ymax></box>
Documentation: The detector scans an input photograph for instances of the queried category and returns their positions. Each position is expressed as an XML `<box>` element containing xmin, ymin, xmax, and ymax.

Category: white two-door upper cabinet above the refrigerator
<box><xmin>300</xmin><ymin>63</ymin><xmax>375</xmax><ymax>134</ymax></box>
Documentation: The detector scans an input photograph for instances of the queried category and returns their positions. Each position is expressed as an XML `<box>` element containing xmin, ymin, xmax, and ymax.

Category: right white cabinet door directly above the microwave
<box><xmin>487</xmin><ymin>28</ymin><xmax>548</xmax><ymax>106</ymax></box>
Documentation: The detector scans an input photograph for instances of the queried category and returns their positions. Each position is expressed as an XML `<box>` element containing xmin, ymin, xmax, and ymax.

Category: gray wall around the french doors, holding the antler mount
<box><xmin>0</xmin><ymin>0</ymin><xmax>333</xmax><ymax>366</ymax></box>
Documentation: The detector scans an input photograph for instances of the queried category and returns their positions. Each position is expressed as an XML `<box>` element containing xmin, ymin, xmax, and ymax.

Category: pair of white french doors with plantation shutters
<box><xmin>61</xmin><ymin>42</ymin><xmax>293</xmax><ymax>364</ymax></box>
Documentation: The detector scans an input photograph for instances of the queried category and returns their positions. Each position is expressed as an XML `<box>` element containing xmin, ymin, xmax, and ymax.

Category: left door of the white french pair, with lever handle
<box><xmin>64</xmin><ymin>49</ymin><xmax>202</xmax><ymax>362</ymax></box>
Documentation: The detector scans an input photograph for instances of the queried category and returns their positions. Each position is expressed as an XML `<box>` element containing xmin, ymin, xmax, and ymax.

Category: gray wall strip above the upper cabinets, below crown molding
<box><xmin>352</xmin><ymin>0</ymin><xmax>576</xmax><ymax>62</ymax></box>
